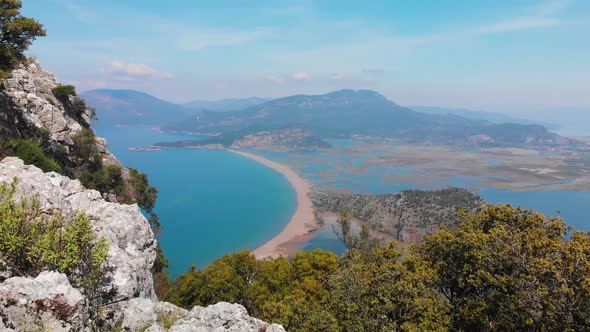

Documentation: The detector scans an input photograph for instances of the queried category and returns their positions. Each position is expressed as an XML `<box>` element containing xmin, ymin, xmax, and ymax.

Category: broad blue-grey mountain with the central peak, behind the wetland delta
<box><xmin>162</xmin><ymin>90</ymin><xmax>572</xmax><ymax>146</ymax></box>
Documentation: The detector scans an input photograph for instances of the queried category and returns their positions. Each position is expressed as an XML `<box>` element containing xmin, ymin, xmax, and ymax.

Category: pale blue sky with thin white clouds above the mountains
<box><xmin>22</xmin><ymin>0</ymin><xmax>590</xmax><ymax>114</ymax></box>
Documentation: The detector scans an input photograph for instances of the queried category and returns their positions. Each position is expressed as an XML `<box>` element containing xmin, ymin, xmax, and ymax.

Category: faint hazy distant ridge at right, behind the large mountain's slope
<box><xmin>408</xmin><ymin>106</ymin><xmax>559</xmax><ymax>130</ymax></box>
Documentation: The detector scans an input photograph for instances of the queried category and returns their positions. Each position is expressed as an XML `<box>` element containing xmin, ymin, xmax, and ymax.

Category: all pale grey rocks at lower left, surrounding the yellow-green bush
<box><xmin>0</xmin><ymin>157</ymin><xmax>284</xmax><ymax>332</ymax></box>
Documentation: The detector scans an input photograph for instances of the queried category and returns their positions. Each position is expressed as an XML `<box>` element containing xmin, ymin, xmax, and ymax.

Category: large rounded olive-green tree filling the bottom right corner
<box><xmin>418</xmin><ymin>205</ymin><xmax>590</xmax><ymax>331</ymax></box>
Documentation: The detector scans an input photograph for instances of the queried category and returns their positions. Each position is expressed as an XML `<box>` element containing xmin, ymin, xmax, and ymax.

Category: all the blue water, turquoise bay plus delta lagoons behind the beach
<box><xmin>94</xmin><ymin>126</ymin><xmax>590</xmax><ymax>277</ymax></box>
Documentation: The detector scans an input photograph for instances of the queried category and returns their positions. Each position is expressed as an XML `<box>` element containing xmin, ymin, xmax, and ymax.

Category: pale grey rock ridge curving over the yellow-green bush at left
<box><xmin>0</xmin><ymin>157</ymin><xmax>156</xmax><ymax>299</ymax></box>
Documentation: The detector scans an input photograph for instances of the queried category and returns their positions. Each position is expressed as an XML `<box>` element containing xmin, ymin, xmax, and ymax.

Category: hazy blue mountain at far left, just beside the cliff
<box><xmin>82</xmin><ymin>89</ymin><xmax>192</xmax><ymax>126</ymax></box>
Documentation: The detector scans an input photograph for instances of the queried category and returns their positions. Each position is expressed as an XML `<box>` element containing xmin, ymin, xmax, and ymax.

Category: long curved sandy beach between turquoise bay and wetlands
<box><xmin>230</xmin><ymin>150</ymin><xmax>318</xmax><ymax>259</ymax></box>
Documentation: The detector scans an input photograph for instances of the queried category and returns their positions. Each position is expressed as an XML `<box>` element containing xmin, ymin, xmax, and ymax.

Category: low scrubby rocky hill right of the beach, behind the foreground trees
<box><xmin>313</xmin><ymin>188</ymin><xmax>485</xmax><ymax>243</ymax></box>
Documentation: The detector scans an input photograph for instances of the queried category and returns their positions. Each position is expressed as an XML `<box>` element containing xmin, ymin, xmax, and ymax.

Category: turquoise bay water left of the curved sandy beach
<box><xmin>95</xmin><ymin>127</ymin><xmax>296</xmax><ymax>276</ymax></box>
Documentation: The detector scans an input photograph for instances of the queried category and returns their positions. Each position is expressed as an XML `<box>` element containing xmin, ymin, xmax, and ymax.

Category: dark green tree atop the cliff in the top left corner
<box><xmin>0</xmin><ymin>0</ymin><xmax>46</xmax><ymax>71</ymax></box>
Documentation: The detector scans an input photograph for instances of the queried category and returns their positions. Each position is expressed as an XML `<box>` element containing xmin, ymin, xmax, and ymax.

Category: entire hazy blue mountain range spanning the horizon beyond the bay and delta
<box><xmin>83</xmin><ymin>90</ymin><xmax>573</xmax><ymax>146</ymax></box>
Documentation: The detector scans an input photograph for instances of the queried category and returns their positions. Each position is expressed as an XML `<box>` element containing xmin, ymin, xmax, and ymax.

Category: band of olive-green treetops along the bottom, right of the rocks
<box><xmin>167</xmin><ymin>205</ymin><xmax>590</xmax><ymax>331</ymax></box>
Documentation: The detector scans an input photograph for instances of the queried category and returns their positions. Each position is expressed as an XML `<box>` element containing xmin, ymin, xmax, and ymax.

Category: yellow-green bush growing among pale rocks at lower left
<box><xmin>0</xmin><ymin>180</ymin><xmax>108</xmax><ymax>291</ymax></box>
